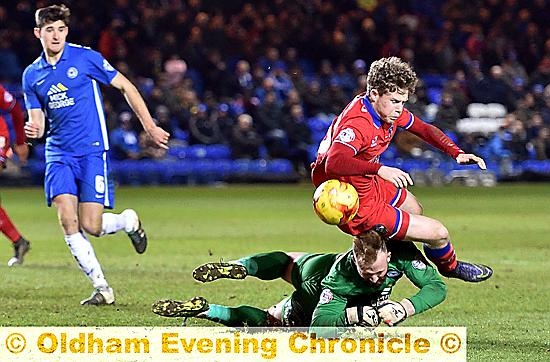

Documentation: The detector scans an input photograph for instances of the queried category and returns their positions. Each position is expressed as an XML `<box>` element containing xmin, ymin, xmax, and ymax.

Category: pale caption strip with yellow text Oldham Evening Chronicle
<box><xmin>0</xmin><ymin>327</ymin><xmax>466</xmax><ymax>362</ymax></box>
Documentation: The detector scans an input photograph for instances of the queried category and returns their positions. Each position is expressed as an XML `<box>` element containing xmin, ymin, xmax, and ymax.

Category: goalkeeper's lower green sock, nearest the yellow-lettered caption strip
<box><xmin>203</xmin><ymin>304</ymin><xmax>267</xmax><ymax>327</ymax></box>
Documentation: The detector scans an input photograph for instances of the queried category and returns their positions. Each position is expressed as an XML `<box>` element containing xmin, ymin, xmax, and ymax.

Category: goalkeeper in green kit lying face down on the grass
<box><xmin>152</xmin><ymin>230</ymin><xmax>447</xmax><ymax>327</ymax></box>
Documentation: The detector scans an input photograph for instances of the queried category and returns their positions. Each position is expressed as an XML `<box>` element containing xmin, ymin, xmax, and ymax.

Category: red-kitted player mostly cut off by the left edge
<box><xmin>0</xmin><ymin>84</ymin><xmax>30</xmax><ymax>266</ymax></box>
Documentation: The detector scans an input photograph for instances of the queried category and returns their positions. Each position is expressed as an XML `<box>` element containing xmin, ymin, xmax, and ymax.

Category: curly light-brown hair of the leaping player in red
<box><xmin>367</xmin><ymin>57</ymin><xmax>418</xmax><ymax>95</ymax></box>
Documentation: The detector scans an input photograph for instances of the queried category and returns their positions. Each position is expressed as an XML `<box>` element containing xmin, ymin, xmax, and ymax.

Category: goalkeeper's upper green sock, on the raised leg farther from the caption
<box><xmin>238</xmin><ymin>251</ymin><xmax>290</xmax><ymax>280</ymax></box>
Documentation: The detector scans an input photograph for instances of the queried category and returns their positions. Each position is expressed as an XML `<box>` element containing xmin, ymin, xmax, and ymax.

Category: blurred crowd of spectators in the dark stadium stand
<box><xmin>0</xmin><ymin>0</ymin><xmax>550</xmax><ymax>181</ymax></box>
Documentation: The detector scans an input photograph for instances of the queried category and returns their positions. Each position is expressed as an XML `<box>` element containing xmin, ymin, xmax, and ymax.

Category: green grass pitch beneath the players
<box><xmin>0</xmin><ymin>184</ymin><xmax>550</xmax><ymax>361</ymax></box>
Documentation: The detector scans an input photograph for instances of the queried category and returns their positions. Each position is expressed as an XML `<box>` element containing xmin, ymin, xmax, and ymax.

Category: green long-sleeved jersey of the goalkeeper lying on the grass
<box><xmin>305</xmin><ymin>242</ymin><xmax>446</xmax><ymax>326</ymax></box>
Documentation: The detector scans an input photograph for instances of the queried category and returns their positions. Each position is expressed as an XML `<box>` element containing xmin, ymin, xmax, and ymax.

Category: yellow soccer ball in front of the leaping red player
<box><xmin>313</xmin><ymin>180</ymin><xmax>359</xmax><ymax>225</ymax></box>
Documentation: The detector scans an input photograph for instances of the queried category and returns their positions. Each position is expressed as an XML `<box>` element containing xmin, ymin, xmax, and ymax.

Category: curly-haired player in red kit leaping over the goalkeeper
<box><xmin>312</xmin><ymin>57</ymin><xmax>493</xmax><ymax>282</ymax></box>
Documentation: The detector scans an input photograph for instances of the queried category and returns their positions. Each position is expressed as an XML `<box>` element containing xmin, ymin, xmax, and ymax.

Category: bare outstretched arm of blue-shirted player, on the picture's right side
<box><xmin>111</xmin><ymin>73</ymin><xmax>170</xmax><ymax>149</ymax></box>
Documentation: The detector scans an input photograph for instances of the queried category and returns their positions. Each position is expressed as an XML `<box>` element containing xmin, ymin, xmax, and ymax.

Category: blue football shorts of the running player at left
<box><xmin>44</xmin><ymin>152</ymin><xmax>115</xmax><ymax>209</ymax></box>
